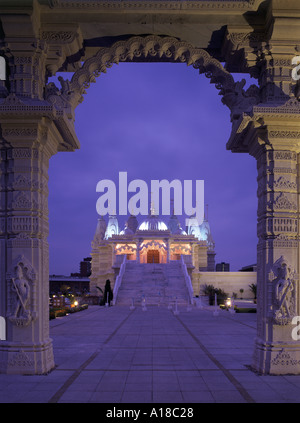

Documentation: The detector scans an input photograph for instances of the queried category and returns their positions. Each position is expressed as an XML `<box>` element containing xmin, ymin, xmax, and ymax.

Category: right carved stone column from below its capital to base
<box><xmin>248</xmin><ymin>121</ymin><xmax>300</xmax><ymax>375</ymax></box>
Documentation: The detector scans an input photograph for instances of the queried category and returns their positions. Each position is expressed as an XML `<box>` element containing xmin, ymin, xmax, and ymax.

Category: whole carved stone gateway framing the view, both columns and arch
<box><xmin>0</xmin><ymin>0</ymin><xmax>300</xmax><ymax>374</ymax></box>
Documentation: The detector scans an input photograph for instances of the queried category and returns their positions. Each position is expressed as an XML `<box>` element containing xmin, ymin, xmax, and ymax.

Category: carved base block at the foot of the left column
<box><xmin>0</xmin><ymin>339</ymin><xmax>55</xmax><ymax>375</ymax></box>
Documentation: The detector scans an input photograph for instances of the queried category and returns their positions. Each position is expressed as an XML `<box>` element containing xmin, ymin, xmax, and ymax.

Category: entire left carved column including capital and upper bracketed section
<box><xmin>0</xmin><ymin>7</ymin><xmax>82</xmax><ymax>374</ymax></box>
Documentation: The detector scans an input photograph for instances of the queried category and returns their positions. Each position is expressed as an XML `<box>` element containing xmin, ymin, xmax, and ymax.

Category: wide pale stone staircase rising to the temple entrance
<box><xmin>116</xmin><ymin>261</ymin><xmax>188</xmax><ymax>305</ymax></box>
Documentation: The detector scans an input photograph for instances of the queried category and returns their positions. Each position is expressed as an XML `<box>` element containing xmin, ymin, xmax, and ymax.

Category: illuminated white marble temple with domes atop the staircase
<box><xmin>90</xmin><ymin>208</ymin><xmax>215</xmax><ymax>302</ymax></box>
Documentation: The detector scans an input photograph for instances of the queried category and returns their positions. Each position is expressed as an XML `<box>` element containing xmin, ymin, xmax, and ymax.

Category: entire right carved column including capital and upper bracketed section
<box><xmin>223</xmin><ymin>18</ymin><xmax>300</xmax><ymax>374</ymax></box>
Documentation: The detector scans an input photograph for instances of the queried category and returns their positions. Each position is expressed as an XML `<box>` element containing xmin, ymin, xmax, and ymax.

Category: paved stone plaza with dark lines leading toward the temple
<box><xmin>0</xmin><ymin>306</ymin><xmax>300</xmax><ymax>404</ymax></box>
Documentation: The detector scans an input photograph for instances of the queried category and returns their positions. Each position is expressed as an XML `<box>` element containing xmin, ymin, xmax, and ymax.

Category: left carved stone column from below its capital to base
<box><xmin>0</xmin><ymin>119</ymin><xmax>57</xmax><ymax>374</ymax></box>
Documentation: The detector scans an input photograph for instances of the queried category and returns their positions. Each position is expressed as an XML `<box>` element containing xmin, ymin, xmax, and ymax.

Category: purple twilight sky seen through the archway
<box><xmin>49</xmin><ymin>63</ymin><xmax>257</xmax><ymax>275</ymax></box>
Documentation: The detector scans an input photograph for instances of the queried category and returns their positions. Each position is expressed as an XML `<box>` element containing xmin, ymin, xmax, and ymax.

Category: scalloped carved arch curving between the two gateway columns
<box><xmin>46</xmin><ymin>35</ymin><xmax>260</xmax><ymax>119</ymax></box>
